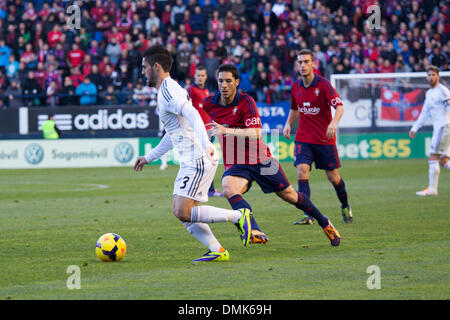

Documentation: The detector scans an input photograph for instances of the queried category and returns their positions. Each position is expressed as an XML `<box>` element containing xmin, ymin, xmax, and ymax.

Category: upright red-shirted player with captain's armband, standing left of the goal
<box><xmin>283</xmin><ymin>49</ymin><xmax>353</xmax><ymax>224</ymax></box>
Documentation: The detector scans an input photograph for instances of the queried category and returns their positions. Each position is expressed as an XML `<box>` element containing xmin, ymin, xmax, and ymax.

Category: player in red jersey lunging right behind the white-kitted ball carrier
<box><xmin>203</xmin><ymin>64</ymin><xmax>341</xmax><ymax>246</ymax></box>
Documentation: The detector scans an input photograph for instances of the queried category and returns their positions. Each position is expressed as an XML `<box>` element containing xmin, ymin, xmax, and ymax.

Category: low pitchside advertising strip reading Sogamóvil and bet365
<box><xmin>0</xmin><ymin>132</ymin><xmax>431</xmax><ymax>169</ymax></box>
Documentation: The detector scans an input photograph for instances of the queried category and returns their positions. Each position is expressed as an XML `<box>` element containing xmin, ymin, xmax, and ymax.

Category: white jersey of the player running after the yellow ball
<box><xmin>158</xmin><ymin>77</ymin><xmax>206</xmax><ymax>162</ymax></box>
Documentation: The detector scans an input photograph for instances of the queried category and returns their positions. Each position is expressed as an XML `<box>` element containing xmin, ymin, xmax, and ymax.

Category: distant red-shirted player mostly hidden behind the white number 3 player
<box><xmin>186</xmin><ymin>65</ymin><xmax>223</xmax><ymax>197</ymax></box>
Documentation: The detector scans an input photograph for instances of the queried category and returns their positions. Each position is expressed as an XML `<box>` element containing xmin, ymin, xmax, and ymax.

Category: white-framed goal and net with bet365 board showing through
<box><xmin>330</xmin><ymin>71</ymin><xmax>450</xmax><ymax>160</ymax></box>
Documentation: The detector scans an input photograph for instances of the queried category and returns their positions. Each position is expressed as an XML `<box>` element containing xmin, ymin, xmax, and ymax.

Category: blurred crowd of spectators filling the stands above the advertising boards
<box><xmin>0</xmin><ymin>0</ymin><xmax>450</xmax><ymax>108</ymax></box>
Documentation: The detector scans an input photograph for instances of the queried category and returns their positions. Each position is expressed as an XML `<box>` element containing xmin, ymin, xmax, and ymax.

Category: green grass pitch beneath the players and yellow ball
<box><xmin>0</xmin><ymin>159</ymin><xmax>450</xmax><ymax>300</ymax></box>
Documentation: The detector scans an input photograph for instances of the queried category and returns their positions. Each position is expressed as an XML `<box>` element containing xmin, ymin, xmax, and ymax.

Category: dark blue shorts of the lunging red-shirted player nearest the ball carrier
<box><xmin>222</xmin><ymin>158</ymin><xmax>290</xmax><ymax>193</ymax></box>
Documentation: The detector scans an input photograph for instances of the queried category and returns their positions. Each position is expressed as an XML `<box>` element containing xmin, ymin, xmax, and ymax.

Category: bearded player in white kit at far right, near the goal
<box><xmin>409</xmin><ymin>66</ymin><xmax>450</xmax><ymax>196</ymax></box>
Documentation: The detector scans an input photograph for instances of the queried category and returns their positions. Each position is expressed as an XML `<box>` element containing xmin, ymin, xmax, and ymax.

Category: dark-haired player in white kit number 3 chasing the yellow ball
<box><xmin>134</xmin><ymin>45</ymin><xmax>251</xmax><ymax>261</ymax></box>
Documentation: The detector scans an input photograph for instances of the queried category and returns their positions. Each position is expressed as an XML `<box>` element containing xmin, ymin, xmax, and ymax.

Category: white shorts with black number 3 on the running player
<box><xmin>173</xmin><ymin>156</ymin><xmax>218</xmax><ymax>202</ymax></box>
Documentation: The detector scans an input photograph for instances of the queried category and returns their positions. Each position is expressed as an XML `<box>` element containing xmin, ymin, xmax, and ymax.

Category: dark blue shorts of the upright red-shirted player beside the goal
<box><xmin>294</xmin><ymin>141</ymin><xmax>341</xmax><ymax>170</ymax></box>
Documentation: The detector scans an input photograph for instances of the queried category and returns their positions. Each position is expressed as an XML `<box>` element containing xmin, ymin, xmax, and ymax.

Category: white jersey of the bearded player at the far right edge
<box><xmin>412</xmin><ymin>83</ymin><xmax>450</xmax><ymax>132</ymax></box>
